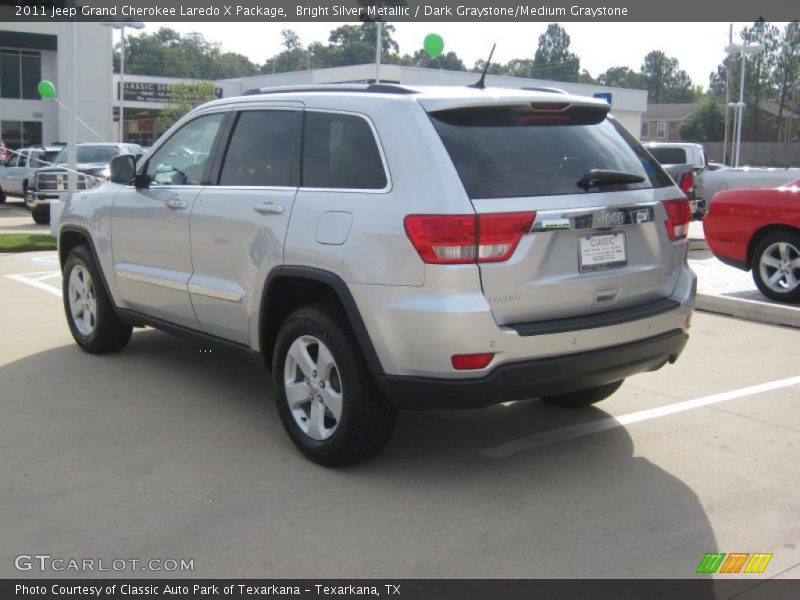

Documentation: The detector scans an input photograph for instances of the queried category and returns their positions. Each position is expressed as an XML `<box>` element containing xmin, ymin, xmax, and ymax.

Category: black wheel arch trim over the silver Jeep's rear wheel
<box><xmin>258</xmin><ymin>266</ymin><xmax>383</xmax><ymax>375</ymax></box>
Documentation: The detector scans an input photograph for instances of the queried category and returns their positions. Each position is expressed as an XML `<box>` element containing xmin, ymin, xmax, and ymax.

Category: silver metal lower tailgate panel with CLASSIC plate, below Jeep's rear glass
<box><xmin>473</xmin><ymin>191</ymin><xmax>684</xmax><ymax>325</ymax></box>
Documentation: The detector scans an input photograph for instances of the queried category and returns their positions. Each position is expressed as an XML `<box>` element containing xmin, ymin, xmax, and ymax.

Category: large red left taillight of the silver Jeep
<box><xmin>405</xmin><ymin>212</ymin><xmax>536</xmax><ymax>265</ymax></box>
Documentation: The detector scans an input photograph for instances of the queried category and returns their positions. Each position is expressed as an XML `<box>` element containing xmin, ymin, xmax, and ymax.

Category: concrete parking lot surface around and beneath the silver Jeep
<box><xmin>0</xmin><ymin>244</ymin><xmax>800</xmax><ymax>584</ymax></box>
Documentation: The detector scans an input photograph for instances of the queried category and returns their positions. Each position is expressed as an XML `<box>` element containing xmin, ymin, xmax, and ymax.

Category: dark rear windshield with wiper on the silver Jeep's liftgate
<box><xmin>430</xmin><ymin>105</ymin><xmax>671</xmax><ymax>198</ymax></box>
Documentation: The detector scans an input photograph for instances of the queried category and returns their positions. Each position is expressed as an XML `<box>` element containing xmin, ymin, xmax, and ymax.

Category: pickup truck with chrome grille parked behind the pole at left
<box><xmin>25</xmin><ymin>143</ymin><xmax>144</xmax><ymax>224</ymax></box>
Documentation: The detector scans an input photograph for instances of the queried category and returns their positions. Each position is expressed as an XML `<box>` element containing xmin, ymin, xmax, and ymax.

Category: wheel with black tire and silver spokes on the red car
<box><xmin>750</xmin><ymin>231</ymin><xmax>800</xmax><ymax>302</ymax></box>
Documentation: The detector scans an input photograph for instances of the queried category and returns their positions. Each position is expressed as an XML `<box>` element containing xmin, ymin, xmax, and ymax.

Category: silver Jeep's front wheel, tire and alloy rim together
<box><xmin>62</xmin><ymin>246</ymin><xmax>132</xmax><ymax>354</ymax></box>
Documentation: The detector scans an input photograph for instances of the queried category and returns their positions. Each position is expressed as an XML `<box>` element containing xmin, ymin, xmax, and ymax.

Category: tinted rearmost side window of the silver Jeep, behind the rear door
<box><xmin>301</xmin><ymin>111</ymin><xmax>387</xmax><ymax>190</ymax></box>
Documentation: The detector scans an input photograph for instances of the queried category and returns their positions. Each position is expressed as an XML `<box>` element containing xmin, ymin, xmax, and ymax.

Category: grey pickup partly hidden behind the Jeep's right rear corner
<box><xmin>645</xmin><ymin>142</ymin><xmax>708</xmax><ymax>219</ymax></box>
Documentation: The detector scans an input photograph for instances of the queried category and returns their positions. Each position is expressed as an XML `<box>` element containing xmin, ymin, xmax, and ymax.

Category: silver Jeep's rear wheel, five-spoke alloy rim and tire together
<box><xmin>272</xmin><ymin>305</ymin><xmax>397</xmax><ymax>467</ymax></box>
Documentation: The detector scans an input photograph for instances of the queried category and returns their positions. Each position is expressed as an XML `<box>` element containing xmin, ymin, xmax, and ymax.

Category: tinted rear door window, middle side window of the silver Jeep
<box><xmin>219</xmin><ymin>110</ymin><xmax>301</xmax><ymax>187</ymax></box>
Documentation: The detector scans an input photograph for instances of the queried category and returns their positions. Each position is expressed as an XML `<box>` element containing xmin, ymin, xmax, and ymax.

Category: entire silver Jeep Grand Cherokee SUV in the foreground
<box><xmin>59</xmin><ymin>85</ymin><xmax>696</xmax><ymax>465</ymax></box>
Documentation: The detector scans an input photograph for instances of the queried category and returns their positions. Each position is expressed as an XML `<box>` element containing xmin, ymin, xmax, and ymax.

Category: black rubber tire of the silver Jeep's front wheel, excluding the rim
<box><xmin>62</xmin><ymin>246</ymin><xmax>133</xmax><ymax>354</ymax></box>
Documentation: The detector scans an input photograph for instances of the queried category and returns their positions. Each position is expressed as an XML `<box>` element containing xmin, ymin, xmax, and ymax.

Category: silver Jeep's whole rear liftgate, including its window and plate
<box><xmin>430</xmin><ymin>98</ymin><xmax>688</xmax><ymax>324</ymax></box>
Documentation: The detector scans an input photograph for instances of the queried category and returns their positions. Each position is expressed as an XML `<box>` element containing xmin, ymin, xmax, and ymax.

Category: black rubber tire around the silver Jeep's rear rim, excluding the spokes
<box><xmin>272</xmin><ymin>305</ymin><xmax>397</xmax><ymax>467</ymax></box>
